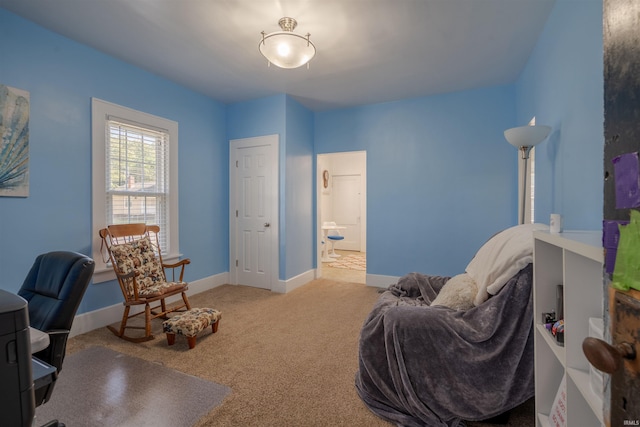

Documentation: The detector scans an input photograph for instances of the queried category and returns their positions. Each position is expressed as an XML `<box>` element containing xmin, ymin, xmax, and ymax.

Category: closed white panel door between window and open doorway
<box><xmin>229</xmin><ymin>135</ymin><xmax>278</xmax><ymax>289</ymax></box>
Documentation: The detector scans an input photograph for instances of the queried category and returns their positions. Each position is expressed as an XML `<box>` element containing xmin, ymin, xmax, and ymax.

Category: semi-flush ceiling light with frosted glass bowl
<box><xmin>258</xmin><ymin>18</ymin><xmax>316</xmax><ymax>68</ymax></box>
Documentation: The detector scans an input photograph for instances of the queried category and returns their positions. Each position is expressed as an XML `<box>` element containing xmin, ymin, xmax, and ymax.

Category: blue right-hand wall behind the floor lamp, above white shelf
<box><xmin>516</xmin><ymin>0</ymin><xmax>604</xmax><ymax>230</ymax></box>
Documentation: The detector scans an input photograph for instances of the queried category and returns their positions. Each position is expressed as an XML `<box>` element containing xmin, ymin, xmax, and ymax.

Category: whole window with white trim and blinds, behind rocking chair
<box><xmin>92</xmin><ymin>98</ymin><xmax>178</xmax><ymax>282</ymax></box>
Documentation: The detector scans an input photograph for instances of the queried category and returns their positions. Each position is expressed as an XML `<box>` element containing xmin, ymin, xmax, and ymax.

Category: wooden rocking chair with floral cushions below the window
<box><xmin>99</xmin><ymin>224</ymin><xmax>191</xmax><ymax>342</ymax></box>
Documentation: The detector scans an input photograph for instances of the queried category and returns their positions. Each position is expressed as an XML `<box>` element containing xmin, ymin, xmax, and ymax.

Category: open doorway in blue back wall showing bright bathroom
<box><xmin>317</xmin><ymin>151</ymin><xmax>367</xmax><ymax>283</ymax></box>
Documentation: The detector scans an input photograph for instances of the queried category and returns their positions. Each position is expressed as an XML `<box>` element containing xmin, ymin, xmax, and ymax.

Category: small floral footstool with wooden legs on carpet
<box><xmin>162</xmin><ymin>308</ymin><xmax>222</xmax><ymax>349</ymax></box>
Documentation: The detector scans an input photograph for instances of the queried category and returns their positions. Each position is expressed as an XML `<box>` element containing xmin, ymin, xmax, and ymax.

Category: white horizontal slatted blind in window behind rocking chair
<box><xmin>105</xmin><ymin>116</ymin><xmax>170</xmax><ymax>253</ymax></box>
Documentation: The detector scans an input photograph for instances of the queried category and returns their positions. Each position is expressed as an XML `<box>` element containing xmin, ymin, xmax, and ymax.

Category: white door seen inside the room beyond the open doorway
<box><xmin>332</xmin><ymin>175</ymin><xmax>361</xmax><ymax>251</ymax></box>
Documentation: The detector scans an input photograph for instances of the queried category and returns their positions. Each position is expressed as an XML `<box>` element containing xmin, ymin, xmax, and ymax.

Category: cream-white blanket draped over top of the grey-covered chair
<box><xmin>466</xmin><ymin>224</ymin><xmax>549</xmax><ymax>306</ymax></box>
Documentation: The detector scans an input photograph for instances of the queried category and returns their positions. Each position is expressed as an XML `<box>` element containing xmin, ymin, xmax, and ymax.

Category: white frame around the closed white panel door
<box><xmin>229</xmin><ymin>134</ymin><xmax>280</xmax><ymax>290</ymax></box>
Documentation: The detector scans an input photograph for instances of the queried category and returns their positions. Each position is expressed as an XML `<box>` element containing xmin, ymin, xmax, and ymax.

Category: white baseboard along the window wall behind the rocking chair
<box><xmin>69</xmin><ymin>272</ymin><xmax>229</xmax><ymax>337</ymax></box>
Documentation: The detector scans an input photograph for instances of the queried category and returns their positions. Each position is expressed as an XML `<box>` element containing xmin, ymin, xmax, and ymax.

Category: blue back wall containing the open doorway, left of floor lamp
<box><xmin>315</xmin><ymin>86</ymin><xmax>517</xmax><ymax>276</ymax></box>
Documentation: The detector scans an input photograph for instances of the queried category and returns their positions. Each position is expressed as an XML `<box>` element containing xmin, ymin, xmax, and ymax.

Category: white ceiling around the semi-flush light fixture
<box><xmin>0</xmin><ymin>0</ymin><xmax>555</xmax><ymax>111</ymax></box>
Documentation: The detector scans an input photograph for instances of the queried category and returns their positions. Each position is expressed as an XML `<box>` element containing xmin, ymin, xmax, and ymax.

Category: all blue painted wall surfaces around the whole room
<box><xmin>0</xmin><ymin>0</ymin><xmax>604</xmax><ymax>318</ymax></box>
